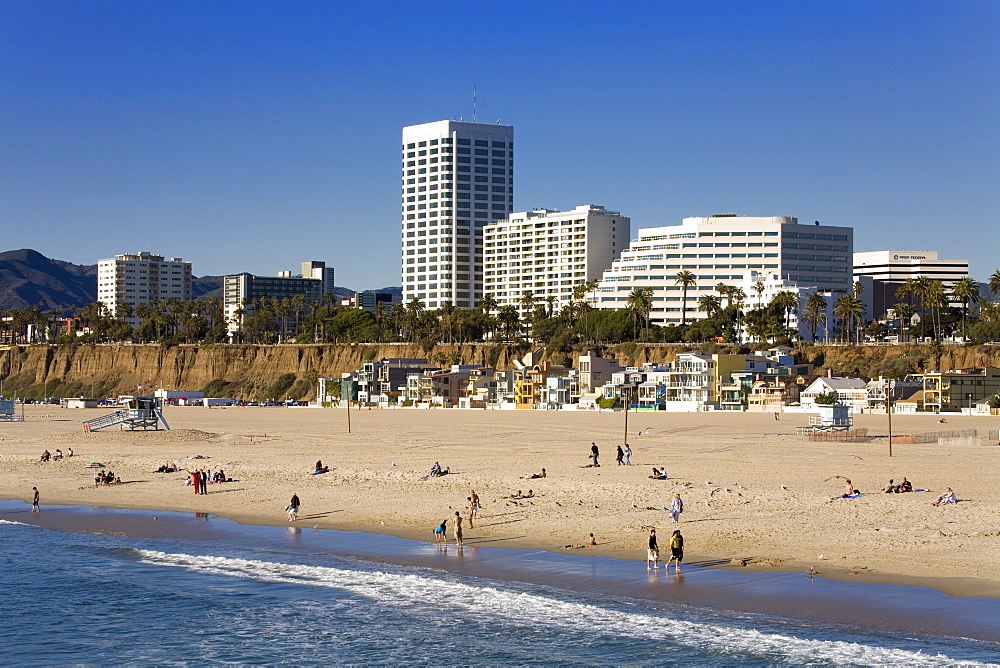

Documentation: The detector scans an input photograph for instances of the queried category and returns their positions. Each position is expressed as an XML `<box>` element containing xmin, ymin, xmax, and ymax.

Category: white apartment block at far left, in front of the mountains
<box><xmin>97</xmin><ymin>251</ymin><xmax>191</xmax><ymax>326</ymax></box>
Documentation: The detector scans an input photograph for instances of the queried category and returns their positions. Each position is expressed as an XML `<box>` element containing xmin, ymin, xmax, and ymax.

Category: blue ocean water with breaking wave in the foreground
<box><xmin>0</xmin><ymin>514</ymin><xmax>1000</xmax><ymax>666</ymax></box>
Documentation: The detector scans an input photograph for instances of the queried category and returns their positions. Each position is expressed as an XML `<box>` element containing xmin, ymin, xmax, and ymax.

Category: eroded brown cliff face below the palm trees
<box><xmin>0</xmin><ymin>344</ymin><xmax>1000</xmax><ymax>399</ymax></box>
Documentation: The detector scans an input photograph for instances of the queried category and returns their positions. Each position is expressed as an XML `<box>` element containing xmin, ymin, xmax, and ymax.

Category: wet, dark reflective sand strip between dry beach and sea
<box><xmin>7</xmin><ymin>500</ymin><xmax>1000</xmax><ymax>643</ymax></box>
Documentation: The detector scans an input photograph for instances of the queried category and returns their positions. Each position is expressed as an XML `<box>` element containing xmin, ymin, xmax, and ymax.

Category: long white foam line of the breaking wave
<box><xmin>133</xmin><ymin>550</ymin><xmax>968</xmax><ymax>665</ymax></box>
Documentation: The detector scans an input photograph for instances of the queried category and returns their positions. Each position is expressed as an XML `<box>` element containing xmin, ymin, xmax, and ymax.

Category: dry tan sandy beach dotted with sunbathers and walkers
<box><xmin>0</xmin><ymin>406</ymin><xmax>1000</xmax><ymax>597</ymax></box>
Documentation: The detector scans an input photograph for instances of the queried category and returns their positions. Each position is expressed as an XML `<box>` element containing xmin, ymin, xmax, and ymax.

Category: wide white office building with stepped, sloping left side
<box><xmin>591</xmin><ymin>214</ymin><xmax>854</xmax><ymax>325</ymax></box>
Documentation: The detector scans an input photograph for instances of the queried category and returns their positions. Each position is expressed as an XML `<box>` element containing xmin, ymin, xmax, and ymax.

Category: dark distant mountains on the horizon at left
<box><xmin>0</xmin><ymin>248</ymin><xmax>402</xmax><ymax>309</ymax></box>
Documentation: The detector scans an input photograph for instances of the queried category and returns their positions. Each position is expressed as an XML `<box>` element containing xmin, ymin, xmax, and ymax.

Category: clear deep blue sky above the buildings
<box><xmin>0</xmin><ymin>0</ymin><xmax>1000</xmax><ymax>289</ymax></box>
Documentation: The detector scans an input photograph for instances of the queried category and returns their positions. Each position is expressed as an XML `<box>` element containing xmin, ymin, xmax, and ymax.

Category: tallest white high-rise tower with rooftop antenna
<box><xmin>402</xmin><ymin>121</ymin><xmax>514</xmax><ymax>308</ymax></box>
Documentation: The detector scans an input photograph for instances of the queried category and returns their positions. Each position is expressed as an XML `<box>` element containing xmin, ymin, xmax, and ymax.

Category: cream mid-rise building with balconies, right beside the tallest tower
<box><xmin>483</xmin><ymin>204</ymin><xmax>631</xmax><ymax>317</ymax></box>
